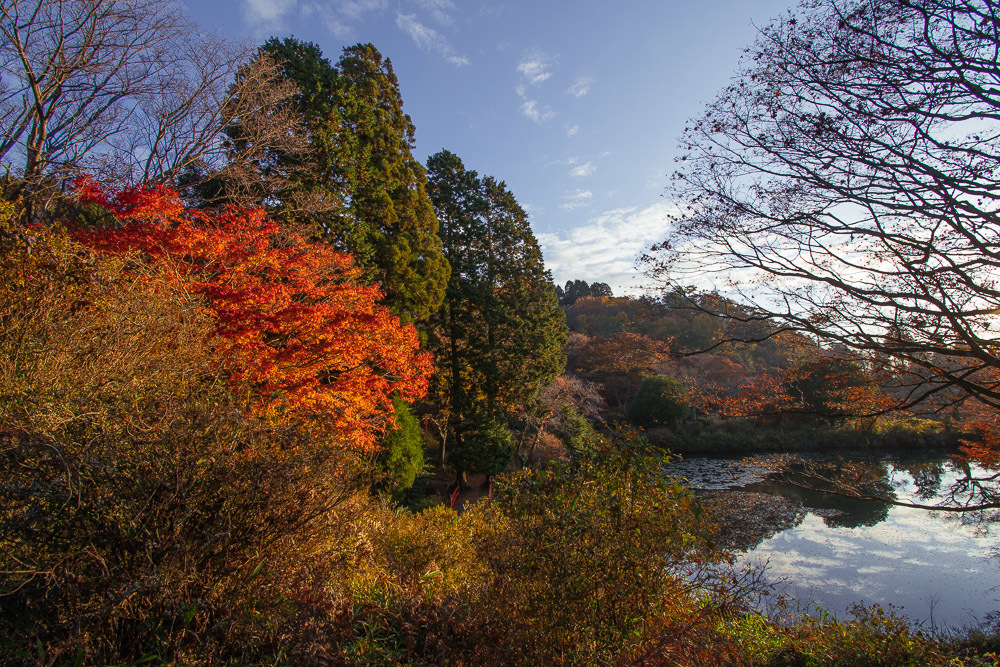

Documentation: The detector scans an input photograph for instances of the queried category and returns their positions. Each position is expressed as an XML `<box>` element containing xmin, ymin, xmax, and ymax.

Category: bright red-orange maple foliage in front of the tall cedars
<box><xmin>76</xmin><ymin>179</ymin><xmax>431</xmax><ymax>449</ymax></box>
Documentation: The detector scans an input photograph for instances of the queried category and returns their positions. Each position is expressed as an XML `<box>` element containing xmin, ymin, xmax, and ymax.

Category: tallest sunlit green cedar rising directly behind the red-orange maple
<box><xmin>262</xmin><ymin>38</ymin><xmax>448</xmax><ymax>322</ymax></box>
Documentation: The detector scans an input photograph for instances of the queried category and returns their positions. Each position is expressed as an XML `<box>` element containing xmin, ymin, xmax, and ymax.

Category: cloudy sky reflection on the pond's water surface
<box><xmin>672</xmin><ymin>457</ymin><xmax>1000</xmax><ymax>629</ymax></box>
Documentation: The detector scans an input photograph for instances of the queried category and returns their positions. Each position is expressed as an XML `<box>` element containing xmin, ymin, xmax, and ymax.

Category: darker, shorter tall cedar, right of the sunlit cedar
<box><xmin>427</xmin><ymin>151</ymin><xmax>566</xmax><ymax>474</ymax></box>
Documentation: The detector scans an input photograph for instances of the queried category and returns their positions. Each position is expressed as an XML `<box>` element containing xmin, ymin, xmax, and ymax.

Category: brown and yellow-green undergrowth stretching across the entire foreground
<box><xmin>0</xmin><ymin>202</ymin><xmax>996</xmax><ymax>665</ymax></box>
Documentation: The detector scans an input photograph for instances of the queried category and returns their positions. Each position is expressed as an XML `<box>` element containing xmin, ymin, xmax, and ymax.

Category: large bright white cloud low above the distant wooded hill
<box><xmin>537</xmin><ymin>204</ymin><xmax>675</xmax><ymax>294</ymax></box>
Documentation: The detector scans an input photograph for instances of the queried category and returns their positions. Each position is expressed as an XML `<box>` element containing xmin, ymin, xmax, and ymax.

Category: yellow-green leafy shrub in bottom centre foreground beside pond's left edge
<box><xmin>467</xmin><ymin>430</ymin><xmax>736</xmax><ymax>664</ymax></box>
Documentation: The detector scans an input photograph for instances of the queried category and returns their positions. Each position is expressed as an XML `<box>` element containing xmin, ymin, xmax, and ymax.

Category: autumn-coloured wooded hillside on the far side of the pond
<box><xmin>564</xmin><ymin>290</ymin><xmax>975</xmax><ymax>451</ymax></box>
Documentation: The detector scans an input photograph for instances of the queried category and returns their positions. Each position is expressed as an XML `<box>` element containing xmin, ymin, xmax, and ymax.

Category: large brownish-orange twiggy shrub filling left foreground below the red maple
<box><xmin>0</xmin><ymin>204</ymin><xmax>376</xmax><ymax>664</ymax></box>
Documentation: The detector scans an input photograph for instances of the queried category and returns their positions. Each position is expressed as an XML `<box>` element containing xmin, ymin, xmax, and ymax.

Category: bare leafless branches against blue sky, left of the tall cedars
<box><xmin>0</xmin><ymin>0</ymin><xmax>305</xmax><ymax>214</ymax></box>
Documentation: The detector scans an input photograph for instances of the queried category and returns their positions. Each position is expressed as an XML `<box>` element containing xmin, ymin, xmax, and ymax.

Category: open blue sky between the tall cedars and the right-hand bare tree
<box><xmin>184</xmin><ymin>0</ymin><xmax>790</xmax><ymax>294</ymax></box>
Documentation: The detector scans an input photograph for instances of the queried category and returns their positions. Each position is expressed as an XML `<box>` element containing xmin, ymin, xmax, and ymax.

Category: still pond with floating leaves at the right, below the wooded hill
<box><xmin>670</xmin><ymin>454</ymin><xmax>1000</xmax><ymax>630</ymax></box>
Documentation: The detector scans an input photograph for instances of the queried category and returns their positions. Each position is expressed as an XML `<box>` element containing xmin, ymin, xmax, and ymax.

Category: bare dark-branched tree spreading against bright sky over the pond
<box><xmin>652</xmin><ymin>0</ymin><xmax>1000</xmax><ymax>406</ymax></box>
